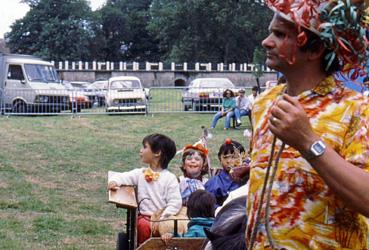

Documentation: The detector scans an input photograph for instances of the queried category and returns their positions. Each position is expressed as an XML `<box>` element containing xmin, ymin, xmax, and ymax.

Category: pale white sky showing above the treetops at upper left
<box><xmin>0</xmin><ymin>0</ymin><xmax>106</xmax><ymax>38</ymax></box>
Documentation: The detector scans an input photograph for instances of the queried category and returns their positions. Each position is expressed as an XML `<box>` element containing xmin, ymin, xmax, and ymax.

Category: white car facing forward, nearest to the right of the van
<box><xmin>105</xmin><ymin>76</ymin><xmax>147</xmax><ymax>112</ymax></box>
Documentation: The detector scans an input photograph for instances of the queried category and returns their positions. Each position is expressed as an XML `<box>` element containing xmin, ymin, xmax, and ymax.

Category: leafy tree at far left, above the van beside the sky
<box><xmin>5</xmin><ymin>0</ymin><xmax>94</xmax><ymax>60</ymax></box>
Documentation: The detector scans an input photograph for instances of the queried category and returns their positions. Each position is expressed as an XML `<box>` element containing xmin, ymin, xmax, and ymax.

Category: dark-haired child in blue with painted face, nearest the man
<box><xmin>205</xmin><ymin>138</ymin><xmax>249</xmax><ymax>206</ymax></box>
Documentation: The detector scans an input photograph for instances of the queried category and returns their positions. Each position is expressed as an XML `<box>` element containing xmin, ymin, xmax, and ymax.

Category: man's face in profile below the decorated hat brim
<box><xmin>262</xmin><ymin>14</ymin><xmax>301</xmax><ymax>72</ymax></box>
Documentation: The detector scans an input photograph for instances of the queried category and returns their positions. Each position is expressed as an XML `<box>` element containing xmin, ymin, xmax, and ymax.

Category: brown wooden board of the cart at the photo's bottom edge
<box><xmin>137</xmin><ymin>237</ymin><xmax>206</xmax><ymax>250</ymax></box>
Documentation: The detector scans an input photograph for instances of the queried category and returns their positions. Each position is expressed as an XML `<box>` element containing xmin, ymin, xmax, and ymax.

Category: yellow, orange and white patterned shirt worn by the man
<box><xmin>246</xmin><ymin>76</ymin><xmax>369</xmax><ymax>250</ymax></box>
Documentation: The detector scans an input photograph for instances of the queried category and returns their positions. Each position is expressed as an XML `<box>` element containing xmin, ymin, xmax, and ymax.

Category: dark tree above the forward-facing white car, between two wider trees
<box><xmin>100</xmin><ymin>0</ymin><xmax>159</xmax><ymax>61</ymax></box>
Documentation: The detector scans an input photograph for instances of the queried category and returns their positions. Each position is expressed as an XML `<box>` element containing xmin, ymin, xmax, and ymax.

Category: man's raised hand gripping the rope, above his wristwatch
<box><xmin>268</xmin><ymin>94</ymin><xmax>319</xmax><ymax>154</ymax></box>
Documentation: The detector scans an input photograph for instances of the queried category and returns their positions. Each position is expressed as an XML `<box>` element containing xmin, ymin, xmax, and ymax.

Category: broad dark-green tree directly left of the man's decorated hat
<box><xmin>148</xmin><ymin>0</ymin><xmax>272</xmax><ymax>63</ymax></box>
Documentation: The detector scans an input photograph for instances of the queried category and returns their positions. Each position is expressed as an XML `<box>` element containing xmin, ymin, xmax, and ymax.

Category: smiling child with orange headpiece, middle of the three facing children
<box><xmin>179</xmin><ymin>144</ymin><xmax>208</xmax><ymax>206</ymax></box>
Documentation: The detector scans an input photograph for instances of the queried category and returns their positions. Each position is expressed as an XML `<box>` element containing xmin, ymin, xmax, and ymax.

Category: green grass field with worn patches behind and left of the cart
<box><xmin>0</xmin><ymin>114</ymin><xmax>247</xmax><ymax>249</ymax></box>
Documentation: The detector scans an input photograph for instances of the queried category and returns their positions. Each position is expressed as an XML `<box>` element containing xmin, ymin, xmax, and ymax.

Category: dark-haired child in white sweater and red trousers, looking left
<box><xmin>108</xmin><ymin>134</ymin><xmax>182</xmax><ymax>244</ymax></box>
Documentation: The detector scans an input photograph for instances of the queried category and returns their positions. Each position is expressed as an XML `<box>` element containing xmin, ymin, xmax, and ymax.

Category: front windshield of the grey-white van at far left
<box><xmin>24</xmin><ymin>64</ymin><xmax>59</xmax><ymax>83</ymax></box>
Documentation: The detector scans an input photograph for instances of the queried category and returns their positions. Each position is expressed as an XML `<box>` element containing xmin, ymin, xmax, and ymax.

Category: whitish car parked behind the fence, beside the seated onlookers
<box><xmin>182</xmin><ymin>78</ymin><xmax>236</xmax><ymax>111</ymax></box>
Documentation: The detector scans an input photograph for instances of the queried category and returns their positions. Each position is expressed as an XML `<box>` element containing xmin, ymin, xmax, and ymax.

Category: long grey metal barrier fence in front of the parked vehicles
<box><xmin>0</xmin><ymin>87</ymin><xmax>251</xmax><ymax>116</ymax></box>
